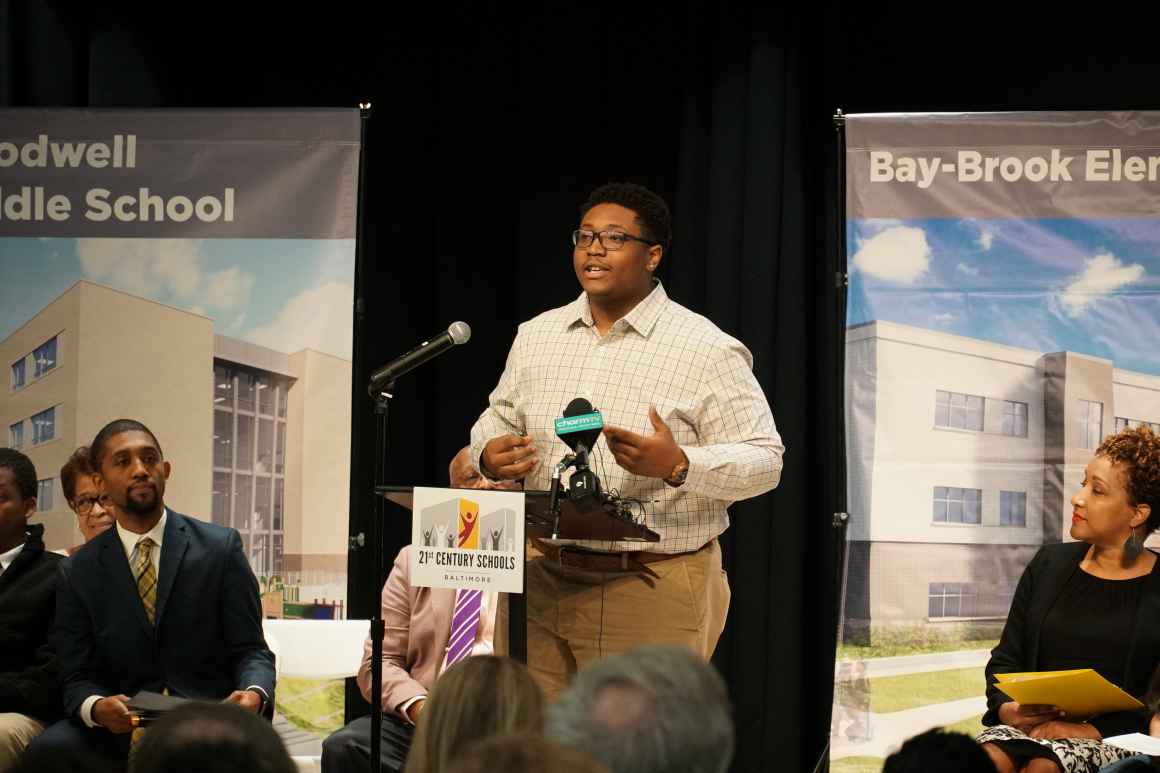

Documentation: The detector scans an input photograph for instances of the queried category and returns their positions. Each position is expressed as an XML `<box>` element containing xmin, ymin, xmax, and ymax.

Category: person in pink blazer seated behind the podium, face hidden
<box><xmin>322</xmin><ymin>448</ymin><xmax>515</xmax><ymax>773</ymax></box>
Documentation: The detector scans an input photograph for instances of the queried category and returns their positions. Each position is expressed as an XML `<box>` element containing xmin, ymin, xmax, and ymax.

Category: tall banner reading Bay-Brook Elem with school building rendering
<box><xmin>832</xmin><ymin>113</ymin><xmax>1160</xmax><ymax>771</ymax></box>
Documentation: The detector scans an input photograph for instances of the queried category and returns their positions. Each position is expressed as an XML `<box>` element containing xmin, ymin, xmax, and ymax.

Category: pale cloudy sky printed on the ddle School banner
<box><xmin>0</xmin><ymin>238</ymin><xmax>355</xmax><ymax>360</ymax></box>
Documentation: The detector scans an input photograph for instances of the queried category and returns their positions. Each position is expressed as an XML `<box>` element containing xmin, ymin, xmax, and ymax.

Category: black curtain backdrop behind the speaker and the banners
<box><xmin>0</xmin><ymin>0</ymin><xmax>1160</xmax><ymax>772</ymax></box>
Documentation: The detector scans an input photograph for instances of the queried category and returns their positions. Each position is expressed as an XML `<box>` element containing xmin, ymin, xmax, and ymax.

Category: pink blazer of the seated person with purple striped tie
<box><xmin>357</xmin><ymin>546</ymin><xmax>455</xmax><ymax>718</ymax></box>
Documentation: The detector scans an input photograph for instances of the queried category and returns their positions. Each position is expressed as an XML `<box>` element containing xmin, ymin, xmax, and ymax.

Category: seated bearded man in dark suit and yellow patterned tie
<box><xmin>28</xmin><ymin>419</ymin><xmax>274</xmax><ymax>770</ymax></box>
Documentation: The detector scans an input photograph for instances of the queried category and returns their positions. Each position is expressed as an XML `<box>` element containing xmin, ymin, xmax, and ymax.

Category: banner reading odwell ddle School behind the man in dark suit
<box><xmin>0</xmin><ymin>109</ymin><xmax>360</xmax><ymax>617</ymax></box>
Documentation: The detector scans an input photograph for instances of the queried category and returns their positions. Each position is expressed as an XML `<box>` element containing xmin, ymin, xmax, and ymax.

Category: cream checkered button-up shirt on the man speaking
<box><xmin>471</xmin><ymin>283</ymin><xmax>785</xmax><ymax>554</ymax></box>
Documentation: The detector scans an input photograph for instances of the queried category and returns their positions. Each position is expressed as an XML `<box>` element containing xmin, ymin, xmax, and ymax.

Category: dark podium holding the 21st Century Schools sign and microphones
<box><xmin>375</xmin><ymin>486</ymin><xmax>660</xmax><ymax>663</ymax></box>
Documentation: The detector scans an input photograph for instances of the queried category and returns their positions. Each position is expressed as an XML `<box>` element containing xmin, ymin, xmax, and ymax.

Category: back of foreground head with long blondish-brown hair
<box><xmin>406</xmin><ymin>655</ymin><xmax>544</xmax><ymax>773</ymax></box>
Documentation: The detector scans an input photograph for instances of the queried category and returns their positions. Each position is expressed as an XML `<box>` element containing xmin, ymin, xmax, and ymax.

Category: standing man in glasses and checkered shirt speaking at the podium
<box><xmin>471</xmin><ymin>183</ymin><xmax>784</xmax><ymax>694</ymax></box>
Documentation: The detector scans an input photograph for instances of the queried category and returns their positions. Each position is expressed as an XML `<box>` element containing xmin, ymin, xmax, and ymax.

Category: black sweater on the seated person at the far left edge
<box><xmin>0</xmin><ymin>525</ymin><xmax>64</xmax><ymax>722</ymax></box>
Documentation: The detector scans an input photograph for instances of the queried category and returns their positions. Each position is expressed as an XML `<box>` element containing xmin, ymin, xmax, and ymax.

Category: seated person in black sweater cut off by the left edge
<box><xmin>0</xmin><ymin>448</ymin><xmax>61</xmax><ymax>772</ymax></box>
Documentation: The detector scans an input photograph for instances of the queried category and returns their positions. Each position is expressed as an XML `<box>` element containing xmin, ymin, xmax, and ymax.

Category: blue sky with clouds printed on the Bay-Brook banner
<box><xmin>847</xmin><ymin>218</ymin><xmax>1160</xmax><ymax>375</ymax></box>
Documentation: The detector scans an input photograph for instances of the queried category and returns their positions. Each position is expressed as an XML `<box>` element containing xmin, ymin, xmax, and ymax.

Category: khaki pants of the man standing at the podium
<box><xmin>495</xmin><ymin>540</ymin><xmax>730</xmax><ymax>699</ymax></box>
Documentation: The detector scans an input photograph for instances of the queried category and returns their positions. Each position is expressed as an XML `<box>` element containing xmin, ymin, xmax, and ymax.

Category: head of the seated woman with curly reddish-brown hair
<box><xmin>1071</xmin><ymin>426</ymin><xmax>1160</xmax><ymax>557</ymax></box>
